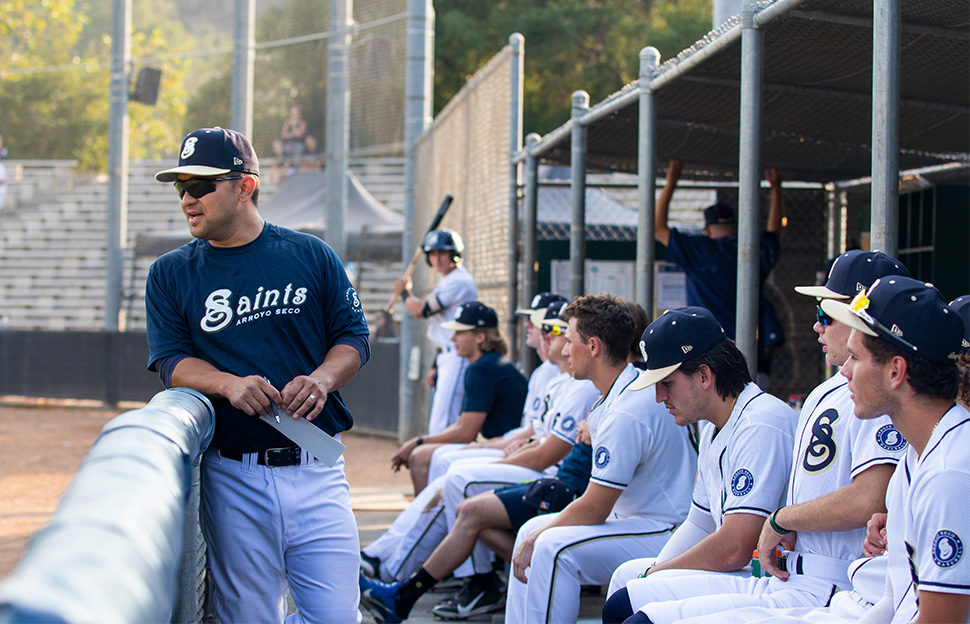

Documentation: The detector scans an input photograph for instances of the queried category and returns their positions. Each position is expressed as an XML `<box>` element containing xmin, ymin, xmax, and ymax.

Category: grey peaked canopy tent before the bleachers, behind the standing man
<box><xmin>135</xmin><ymin>169</ymin><xmax>404</xmax><ymax>260</ymax></box>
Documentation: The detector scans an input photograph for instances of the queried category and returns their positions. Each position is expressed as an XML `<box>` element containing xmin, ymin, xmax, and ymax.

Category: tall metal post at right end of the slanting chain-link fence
<box><xmin>507</xmin><ymin>33</ymin><xmax>525</xmax><ymax>361</ymax></box>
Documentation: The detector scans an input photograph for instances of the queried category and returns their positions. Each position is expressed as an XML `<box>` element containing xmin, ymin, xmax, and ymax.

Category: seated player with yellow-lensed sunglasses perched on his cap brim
<box><xmin>691</xmin><ymin>277</ymin><xmax>970</xmax><ymax>624</ymax></box>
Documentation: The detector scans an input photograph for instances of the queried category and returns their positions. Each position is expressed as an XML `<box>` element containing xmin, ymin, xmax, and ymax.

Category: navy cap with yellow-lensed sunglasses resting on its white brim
<box><xmin>822</xmin><ymin>275</ymin><xmax>964</xmax><ymax>363</ymax></box>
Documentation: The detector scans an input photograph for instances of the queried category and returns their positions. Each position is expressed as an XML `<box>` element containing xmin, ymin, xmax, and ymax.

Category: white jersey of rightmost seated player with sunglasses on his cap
<box><xmin>886</xmin><ymin>405</ymin><xmax>970</xmax><ymax>624</ymax></box>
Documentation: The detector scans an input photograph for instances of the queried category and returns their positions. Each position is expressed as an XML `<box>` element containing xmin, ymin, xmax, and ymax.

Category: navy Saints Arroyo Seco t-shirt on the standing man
<box><xmin>145</xmin><ymin>223</ymin><xmax>368</xmax><ymax>453</ymax></box>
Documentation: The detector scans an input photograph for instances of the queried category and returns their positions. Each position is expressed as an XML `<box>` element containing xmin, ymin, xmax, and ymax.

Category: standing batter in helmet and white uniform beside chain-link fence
<box><xmin>394</xmin><ymin>228</ymin><xmax>478</xmax><ymax>435</ymax></box>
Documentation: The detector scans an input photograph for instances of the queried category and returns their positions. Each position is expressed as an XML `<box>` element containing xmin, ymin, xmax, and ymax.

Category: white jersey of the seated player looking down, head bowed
<box><xmin>692</xmin><ymin>383</ymin><xmax>798</xmax><ymax>529</ymax></box>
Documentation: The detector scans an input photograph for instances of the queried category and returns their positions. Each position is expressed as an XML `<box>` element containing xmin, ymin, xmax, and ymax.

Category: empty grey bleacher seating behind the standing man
<box><xmin>0</xmin><ymin>158</ymin><xmax>404</xmax><ymax>330</ymax></box>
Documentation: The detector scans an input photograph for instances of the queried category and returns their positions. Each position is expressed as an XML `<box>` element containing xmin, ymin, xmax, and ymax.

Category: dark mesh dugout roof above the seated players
<box><xmin>532</xmin><ymin>0</ymin><xmax>970</xmax><ymax>182</ymax></box>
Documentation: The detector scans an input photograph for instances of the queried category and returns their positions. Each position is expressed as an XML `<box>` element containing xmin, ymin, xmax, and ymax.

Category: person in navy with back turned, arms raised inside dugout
<box><xmin>654</xmin><ymin>160</ymin><xmax>785</xmax><ymax>372</ymax></box>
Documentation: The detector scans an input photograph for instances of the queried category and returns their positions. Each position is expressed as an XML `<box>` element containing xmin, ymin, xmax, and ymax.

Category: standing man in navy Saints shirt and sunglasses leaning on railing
<box><xmin>145</xmin><ymin>128</ymin><xmax>370</xmax><ymax>622</ymax></box>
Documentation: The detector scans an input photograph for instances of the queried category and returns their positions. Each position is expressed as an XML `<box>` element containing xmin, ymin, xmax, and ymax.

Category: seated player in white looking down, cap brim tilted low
<box><xmin>603</xmin><ymin>307</ymin><xmax>798</xmax><ymax>623</ymax></box>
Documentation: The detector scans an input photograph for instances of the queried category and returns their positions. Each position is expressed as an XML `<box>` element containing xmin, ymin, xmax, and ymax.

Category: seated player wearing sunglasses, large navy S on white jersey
<box><xmin>616</xmin><ymin>250</ymin><xmax>908</xmax><ymax>624</ymax></box>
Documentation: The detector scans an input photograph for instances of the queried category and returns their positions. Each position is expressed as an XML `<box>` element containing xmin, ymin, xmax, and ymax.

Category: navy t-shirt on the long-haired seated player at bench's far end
<box><xmin>461</xmin><ymin>351</ymin><xmax>529</xmax><ymax>438</ymax></box>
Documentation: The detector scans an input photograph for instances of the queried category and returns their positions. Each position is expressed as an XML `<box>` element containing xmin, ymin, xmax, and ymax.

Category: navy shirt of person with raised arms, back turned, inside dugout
<box><xmin>665</xmin><ymin>229</ymin><xmax>784</xmax><ymax>344</ymax></box>
